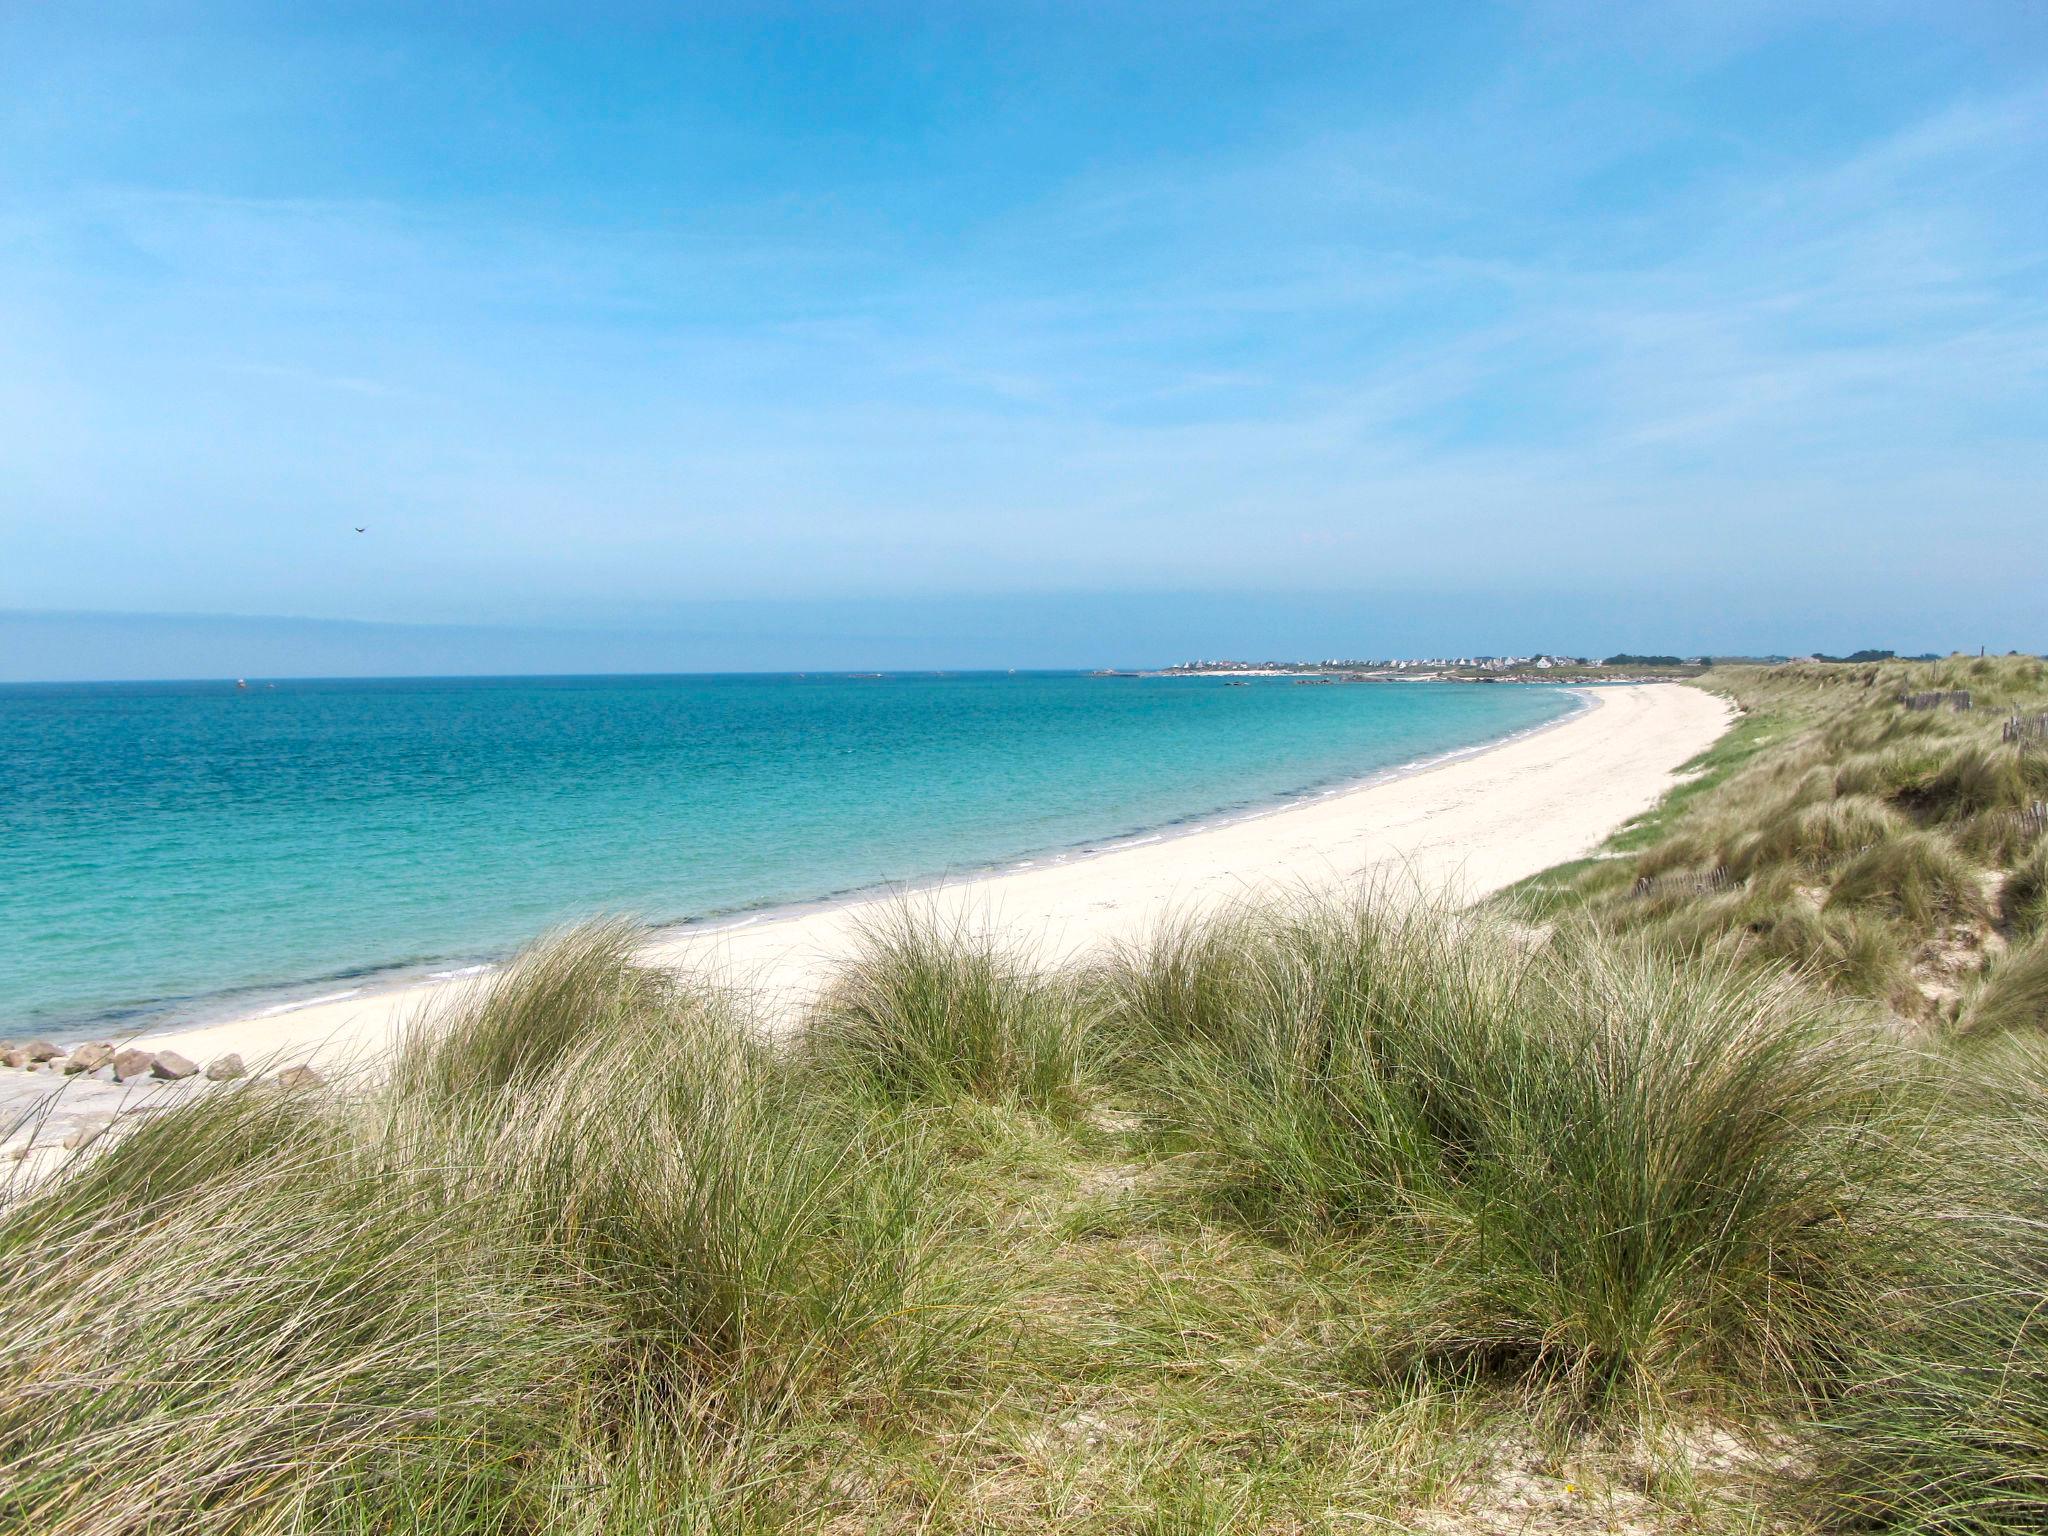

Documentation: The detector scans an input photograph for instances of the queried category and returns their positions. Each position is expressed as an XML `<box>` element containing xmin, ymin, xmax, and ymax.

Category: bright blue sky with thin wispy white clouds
<box><xmin>0</xmin><ymin>0</ymin><xmax>2048</xmax><ymax>676</ymax></box>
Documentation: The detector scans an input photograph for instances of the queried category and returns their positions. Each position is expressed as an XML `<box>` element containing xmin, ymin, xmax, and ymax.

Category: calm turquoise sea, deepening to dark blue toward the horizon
<box><xmin>0</xmin><ymin>674</ymin><xmax>1573</xmax><ymax>1036</ymax></box>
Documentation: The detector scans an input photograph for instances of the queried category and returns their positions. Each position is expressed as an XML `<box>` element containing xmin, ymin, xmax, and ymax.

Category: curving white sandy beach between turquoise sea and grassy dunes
<box><xmin>119</xmin><ymin>684</ymin><xmax>1733</xmax><ymax>1065</ymax></box>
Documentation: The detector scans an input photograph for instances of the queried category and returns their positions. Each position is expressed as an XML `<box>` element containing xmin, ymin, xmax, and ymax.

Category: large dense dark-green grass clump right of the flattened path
<box><xmin>1120</xmin><ymin>903</ymin><xmax>1909</xmax><ymax>1401</ymax></box>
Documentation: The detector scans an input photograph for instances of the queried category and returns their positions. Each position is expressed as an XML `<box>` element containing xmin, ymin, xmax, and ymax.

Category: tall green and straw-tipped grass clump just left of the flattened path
<box><xmin>459</xmin><ymin>991</ymin><xmax>981</xmax><ymax>1421</ymax></box>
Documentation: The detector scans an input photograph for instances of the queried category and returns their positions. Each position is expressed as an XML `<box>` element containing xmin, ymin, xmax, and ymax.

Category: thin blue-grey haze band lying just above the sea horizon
<box><xmin>0</xmin><ymin>594</ymin><xmax>2011</xmax><ymax>684</ymax></box>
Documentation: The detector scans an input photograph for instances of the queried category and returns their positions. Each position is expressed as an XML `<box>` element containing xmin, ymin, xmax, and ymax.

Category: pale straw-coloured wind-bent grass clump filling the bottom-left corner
<box><xmin>0</xmin><ymin>1087</ymin><xmax>602</xmax><ymax>1534</ymax></box>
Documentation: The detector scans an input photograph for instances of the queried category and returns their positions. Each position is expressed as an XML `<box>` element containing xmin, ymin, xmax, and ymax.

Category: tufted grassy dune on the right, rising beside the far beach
<box><xmin>1503</xmin><ymin>657</ymin><xmax>2048</xmax><ymax>1028</ymax></box>
